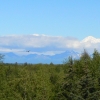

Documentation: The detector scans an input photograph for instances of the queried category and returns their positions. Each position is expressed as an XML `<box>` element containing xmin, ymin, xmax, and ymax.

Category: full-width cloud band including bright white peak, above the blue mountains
<box><xmin>0</xmin><ymin>34</ymin><xmax>100</xmax><ymax>55</ymax></box>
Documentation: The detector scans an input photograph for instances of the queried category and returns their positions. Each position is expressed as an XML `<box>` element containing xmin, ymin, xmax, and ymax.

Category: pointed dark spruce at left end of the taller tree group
<box><xmin>56</xmin><ymin>57</ymin><xmax>83</xmax><ymax>100</ymax></box>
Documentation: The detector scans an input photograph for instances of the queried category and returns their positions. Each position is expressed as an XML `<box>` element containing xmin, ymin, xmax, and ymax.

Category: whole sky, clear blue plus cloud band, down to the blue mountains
<box><xmin>0</xmin><ymin>0</ymin><xmax>100</xmax><ymax>55</ymax></box>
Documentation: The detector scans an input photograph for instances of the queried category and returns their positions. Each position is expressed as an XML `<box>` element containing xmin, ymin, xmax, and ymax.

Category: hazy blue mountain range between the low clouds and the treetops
<box><xmin>4</xmin><ymin>50</ymin><xmax>79</xmax><ymax>64</ymax></box>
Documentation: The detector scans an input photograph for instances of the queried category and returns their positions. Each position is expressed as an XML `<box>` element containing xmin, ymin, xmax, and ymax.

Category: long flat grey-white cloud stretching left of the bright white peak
<box><xmin>0</xmin><ymin>34</ymin><xmax>78</xmax><ymax>47</ymax></box>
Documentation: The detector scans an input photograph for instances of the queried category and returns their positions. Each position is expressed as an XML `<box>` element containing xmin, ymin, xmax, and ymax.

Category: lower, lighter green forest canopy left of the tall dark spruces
<box><xmin>0</xmin><ymin>64</ymin><xmax>64</xmax><ymax>100</ymax></box>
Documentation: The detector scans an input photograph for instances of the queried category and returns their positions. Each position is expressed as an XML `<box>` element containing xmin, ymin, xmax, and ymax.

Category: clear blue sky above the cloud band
<box><xmin>0</xmin><ymin>0</ymin><xmax>100</xmax><ymax>40</ymax></box>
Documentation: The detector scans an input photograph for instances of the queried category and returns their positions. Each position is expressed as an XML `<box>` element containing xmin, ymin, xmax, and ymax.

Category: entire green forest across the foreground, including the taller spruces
<box><xmin>0</xmin><ymin>50</ymin><xmax>100</xmax><ymax>100</ymax></box>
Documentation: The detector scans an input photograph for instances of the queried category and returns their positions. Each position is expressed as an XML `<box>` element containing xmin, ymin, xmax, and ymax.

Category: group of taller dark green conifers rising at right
<box><xmin>56</xmin><ymin>50</ymin><xmax>100</xmax><ymax>100</ymax></box>
